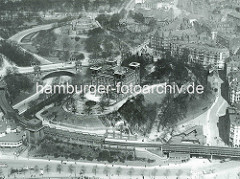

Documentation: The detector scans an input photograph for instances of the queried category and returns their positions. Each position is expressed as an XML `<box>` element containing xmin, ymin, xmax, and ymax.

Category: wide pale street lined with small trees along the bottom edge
<box><xmin>0</xmin><ymin>156</ymin><xmax>240</xmax><ymax>179</ymax></box>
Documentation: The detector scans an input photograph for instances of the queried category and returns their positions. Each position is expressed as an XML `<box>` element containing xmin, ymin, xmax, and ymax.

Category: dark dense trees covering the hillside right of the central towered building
<box><xmin>119</xmin><ymin>54</ymin><xmax>211</xmax><ymax>129</ymax></box>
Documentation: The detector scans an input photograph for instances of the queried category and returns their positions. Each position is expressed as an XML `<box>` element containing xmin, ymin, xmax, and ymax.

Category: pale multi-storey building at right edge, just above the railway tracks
<box><xmin>228</xmin><ymin>108</ymin><xmax>240</xmax><ymax>147</ymax></box>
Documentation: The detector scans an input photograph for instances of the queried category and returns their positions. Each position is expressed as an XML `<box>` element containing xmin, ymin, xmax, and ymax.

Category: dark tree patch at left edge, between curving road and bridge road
<box><xmin>0</xmin><ymin>41</ymin><xmax>40</xmax><ymax>66</ymax></box>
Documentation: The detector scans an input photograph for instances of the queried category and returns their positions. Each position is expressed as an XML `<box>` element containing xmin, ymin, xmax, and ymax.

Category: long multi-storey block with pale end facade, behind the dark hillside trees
<box><xmin>175</xmin><ymin>43</ymin><xmax>230</xmax><ymax>70</ymax></box>
